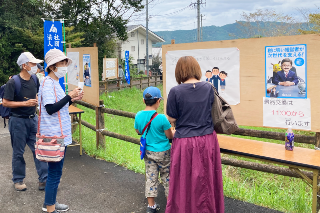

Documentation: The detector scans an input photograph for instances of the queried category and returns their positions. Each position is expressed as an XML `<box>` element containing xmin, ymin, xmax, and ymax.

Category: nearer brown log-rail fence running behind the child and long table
<box><xmin>75</xmin><ymin>101</ymin><xmax>320</xmax><ymax>178</ymax></box>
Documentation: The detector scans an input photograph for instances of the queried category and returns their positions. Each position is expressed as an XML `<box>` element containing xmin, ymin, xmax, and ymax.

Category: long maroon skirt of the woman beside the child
<box><xmin>166</xmin><ymin>132</ymin><xmax>224</xmax><ymax>213</ymax></box>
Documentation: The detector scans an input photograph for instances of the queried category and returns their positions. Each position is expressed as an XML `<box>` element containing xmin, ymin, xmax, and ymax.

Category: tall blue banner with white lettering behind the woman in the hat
<box><xmin>44</xmin><ymin>21</ymin><xmax>65</xmax><ymax>91</ymax></box>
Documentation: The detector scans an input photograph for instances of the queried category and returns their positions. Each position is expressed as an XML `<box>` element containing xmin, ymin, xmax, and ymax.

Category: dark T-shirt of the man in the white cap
<box><xmin>3</xmin><ymin>75</ymin><xmax>40</xmax><ymax>116</ymax></box>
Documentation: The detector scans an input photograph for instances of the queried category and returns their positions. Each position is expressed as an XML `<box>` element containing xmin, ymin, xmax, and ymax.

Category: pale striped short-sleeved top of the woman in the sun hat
<box><xmin>38</xmin><ymin>76</ymin><xmax>72</xmax><ymax>146</ymax></box>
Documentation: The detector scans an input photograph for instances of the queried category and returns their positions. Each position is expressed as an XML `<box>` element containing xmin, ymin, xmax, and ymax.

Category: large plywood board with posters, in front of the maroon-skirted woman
<box><xmin>162</xmin><ymin>34</ymin><xmax>320</xmax><ymax>132</ymax></box>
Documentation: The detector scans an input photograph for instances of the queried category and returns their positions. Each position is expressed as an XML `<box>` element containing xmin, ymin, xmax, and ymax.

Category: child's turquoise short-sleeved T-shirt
<box><xmin>134</xmin><ymin>110</ymin><xmax>171</xmax><ymax>152</ymax></box>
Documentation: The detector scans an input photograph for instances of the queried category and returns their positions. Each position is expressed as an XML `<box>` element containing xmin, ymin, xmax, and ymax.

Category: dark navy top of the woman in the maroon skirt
<box><xmin>167</xmin><ymin>82</ymin><xmax>214</xmax><ymax>138</ymax></box>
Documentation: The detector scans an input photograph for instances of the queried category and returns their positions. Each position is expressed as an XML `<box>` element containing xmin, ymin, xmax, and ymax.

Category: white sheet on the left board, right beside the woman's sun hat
<box><xmin>67</xmin><ymin>52</ymin><xmax>80</xmax><ymax>86</ymax></box>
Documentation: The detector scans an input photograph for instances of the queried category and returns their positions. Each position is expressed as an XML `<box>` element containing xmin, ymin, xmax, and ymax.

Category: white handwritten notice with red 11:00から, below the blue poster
<box><xmin>263</xmin><ymin>97</ymin><xmax>311</xmax><ymax>130</ymax></box>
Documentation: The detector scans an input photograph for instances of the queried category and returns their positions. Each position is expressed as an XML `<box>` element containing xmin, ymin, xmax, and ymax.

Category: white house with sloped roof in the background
<box><xmin>118</xmin><ymin>25</ymin><xmax>164</xmax><ymax>71</ymax></box>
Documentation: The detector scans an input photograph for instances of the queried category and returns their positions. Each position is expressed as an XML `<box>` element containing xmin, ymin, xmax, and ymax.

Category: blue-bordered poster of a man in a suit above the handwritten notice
<box><xmin>265</xmin><ymin>44</ymin><xmax>307</xmax><ymax>99</ymax></box>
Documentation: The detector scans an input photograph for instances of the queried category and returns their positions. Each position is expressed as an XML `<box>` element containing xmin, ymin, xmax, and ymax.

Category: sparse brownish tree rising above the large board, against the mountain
<box><xmin>236</xmin><ymin>9</ymin><xmax>303</xmax><ymax>38</ymax></box>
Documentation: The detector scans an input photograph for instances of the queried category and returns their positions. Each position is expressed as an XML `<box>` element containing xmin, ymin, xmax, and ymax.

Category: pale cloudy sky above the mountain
<box><xmin>129</xmin><ymin>0</ymin><xmax>320</xmax><ymax>31</ymax></box>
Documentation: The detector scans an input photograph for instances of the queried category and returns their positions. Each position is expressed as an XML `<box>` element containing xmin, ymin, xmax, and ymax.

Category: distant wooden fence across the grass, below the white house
<box><xmin>99</xmin><ymin>73</ymin><xmax>163</xmax><ymax>93</ymax></box>
